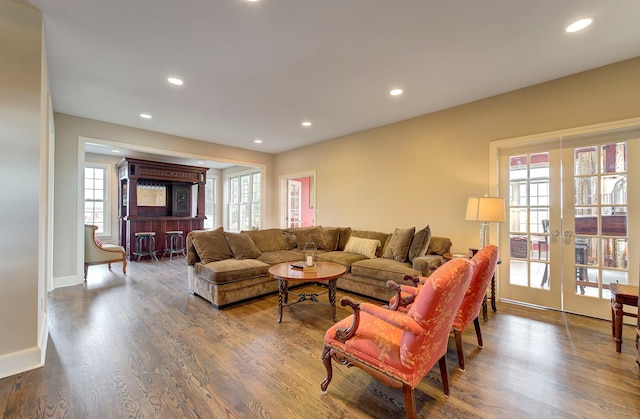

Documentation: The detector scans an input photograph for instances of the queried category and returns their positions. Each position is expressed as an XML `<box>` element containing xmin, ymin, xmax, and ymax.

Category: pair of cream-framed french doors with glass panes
<box><xmin>499</xmin><ymin>134</ymin><xmax>640</xmax><ymax>319</ymax></box>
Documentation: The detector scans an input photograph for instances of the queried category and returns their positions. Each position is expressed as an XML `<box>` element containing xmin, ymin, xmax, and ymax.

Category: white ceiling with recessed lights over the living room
<box><xmin>31</xmin><ymin>0</ymin><xmax>640</xmax><ymax>153</ymax></box>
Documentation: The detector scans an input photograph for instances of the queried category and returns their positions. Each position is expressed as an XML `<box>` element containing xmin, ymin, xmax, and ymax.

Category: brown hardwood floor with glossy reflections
<box><xmin>0</xmin><ymin>258</ymin><xmax>640</xmax><ymax>418</ymax></box>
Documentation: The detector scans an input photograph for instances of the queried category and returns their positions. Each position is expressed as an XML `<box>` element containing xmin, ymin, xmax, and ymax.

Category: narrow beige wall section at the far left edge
<box><xmin>0</xmin><ymin>0</ymin><xmax>47</xmax><ymax>378</ymax></box>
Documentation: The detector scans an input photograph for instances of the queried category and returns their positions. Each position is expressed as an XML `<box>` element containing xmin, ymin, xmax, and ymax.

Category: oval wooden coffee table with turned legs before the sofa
<box><xmin>269</xmin><ymin>262</ymin><xmax>347</xmax><ymax>323</ymax></box>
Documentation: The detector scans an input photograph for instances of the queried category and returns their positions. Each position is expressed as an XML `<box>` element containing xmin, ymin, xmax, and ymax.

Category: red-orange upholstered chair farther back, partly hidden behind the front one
<box><xmin>389</xmin><ymin>244</ymin><xmax>498</xmax><ymax>371</ymax></box>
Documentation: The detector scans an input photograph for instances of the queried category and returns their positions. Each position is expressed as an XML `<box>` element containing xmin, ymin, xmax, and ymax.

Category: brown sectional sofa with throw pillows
<box><xmin>186</xmin><ymin>226</ymin><xmax>452</xmax><ymax>308</ymax></box>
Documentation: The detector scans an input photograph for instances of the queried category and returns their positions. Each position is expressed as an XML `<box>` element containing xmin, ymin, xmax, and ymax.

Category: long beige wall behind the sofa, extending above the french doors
<box><xmin>272</xmin><ymin>57</ymin><xmax>640</xmax><ymax>252</ymax></box>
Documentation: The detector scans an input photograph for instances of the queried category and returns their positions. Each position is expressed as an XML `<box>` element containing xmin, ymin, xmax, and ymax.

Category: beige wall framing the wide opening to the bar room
<box><xmin>53</xmin><ymin>113</ymin><xmax>274</xmax><ymax>284</ymax></box>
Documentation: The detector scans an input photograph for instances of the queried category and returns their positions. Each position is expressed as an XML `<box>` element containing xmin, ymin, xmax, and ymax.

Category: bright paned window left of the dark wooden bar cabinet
<box><xmin>84</xmin><ymin>164</ymin><xmax>110</xmax><ymax>236</ymax></box>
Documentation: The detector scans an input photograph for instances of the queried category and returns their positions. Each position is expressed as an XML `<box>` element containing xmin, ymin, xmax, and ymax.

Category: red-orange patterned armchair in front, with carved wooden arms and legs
<box><xmin>320</xmin><ymin>259</ymin><xmax>473</xmax><ymax>418</ymax></box>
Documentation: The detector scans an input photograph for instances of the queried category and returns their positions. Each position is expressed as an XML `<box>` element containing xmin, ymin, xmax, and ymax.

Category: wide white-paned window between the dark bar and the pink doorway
<box><xmin>228</xmin><ymin>172</ymin><xmax>262</xmax><ymax>231</ymax></box>
